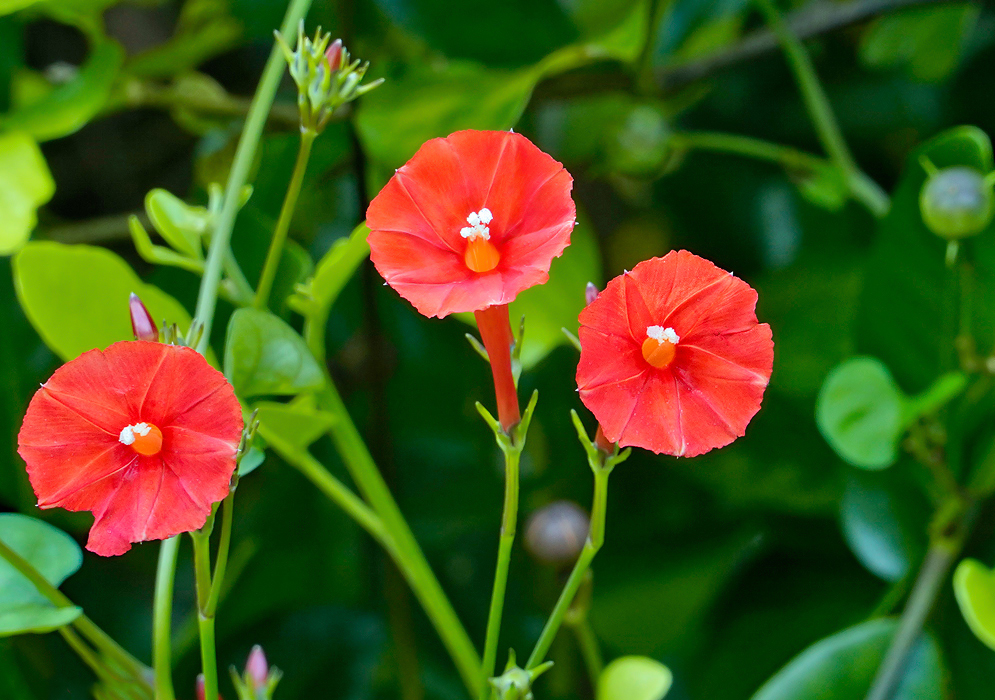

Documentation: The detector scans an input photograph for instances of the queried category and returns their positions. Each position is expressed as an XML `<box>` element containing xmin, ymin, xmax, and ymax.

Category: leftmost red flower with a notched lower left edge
<box><xmin>17</xmin><ymin>341</ymin><xmax>242</xmax><ymax>556</ymax></box>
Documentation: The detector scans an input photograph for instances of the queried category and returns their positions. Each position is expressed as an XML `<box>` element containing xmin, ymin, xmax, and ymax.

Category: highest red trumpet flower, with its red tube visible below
<box><xmin>366</xmin><ymin>131</ymin><xmax>576</xmax><ymax>318</ymax></box>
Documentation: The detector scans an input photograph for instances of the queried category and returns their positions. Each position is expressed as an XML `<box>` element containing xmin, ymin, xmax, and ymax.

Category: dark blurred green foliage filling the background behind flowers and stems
<box><xmin>0</xmin><ymin>0</ymin><xmax>995</xmax><ymax>700</ymax></box>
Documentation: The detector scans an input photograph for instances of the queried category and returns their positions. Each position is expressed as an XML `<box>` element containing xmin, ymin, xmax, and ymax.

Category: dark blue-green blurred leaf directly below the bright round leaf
<box><xmin>840</xmin><ymin>469</ymin><xmax>931</xmax><ymax>582</ymax></box>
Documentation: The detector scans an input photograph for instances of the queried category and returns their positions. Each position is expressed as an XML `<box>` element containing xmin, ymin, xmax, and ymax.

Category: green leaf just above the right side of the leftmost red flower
<box><xmin>225</xmin><ymin>309</ymin><xmax>325</xmax><ymax>397</ymax></box>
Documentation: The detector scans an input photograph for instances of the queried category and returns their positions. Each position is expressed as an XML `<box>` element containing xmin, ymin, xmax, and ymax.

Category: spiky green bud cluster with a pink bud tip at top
<box><xmin>276</xmin><ymin>22</ymin><xmax>383</xmax><ymax>133</ymax></box>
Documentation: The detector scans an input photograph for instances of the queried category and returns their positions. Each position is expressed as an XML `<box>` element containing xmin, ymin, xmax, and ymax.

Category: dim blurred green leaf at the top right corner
<box><xmin>860</xmin><ymin>3</ymin><xmax>978</xmax><ymax>82</ymax></box>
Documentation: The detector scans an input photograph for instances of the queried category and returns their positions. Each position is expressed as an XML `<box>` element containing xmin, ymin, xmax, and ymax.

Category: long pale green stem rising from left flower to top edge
<box><xmin>194</xmin><ymin>0</ymin><xmax>311</xmax><ymax>352</ymax></box>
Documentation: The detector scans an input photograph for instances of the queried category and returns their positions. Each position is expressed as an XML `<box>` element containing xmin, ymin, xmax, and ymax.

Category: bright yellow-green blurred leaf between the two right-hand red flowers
<box><xmin>510</xmin><ymin>212</ymin><xmax>601</xmax><ymax>369</ymax></box>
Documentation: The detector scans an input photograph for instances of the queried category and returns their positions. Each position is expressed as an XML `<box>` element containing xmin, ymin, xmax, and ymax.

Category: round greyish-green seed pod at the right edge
<box><xmin>919</xmin><ymin>166</ymin><xmax>995</xmax><ymax>241</ymax></box>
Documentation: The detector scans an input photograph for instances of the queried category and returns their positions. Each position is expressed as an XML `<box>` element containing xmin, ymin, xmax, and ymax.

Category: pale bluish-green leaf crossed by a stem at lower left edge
<box><xmin>0</xmin><ymin>513</ymin><xmax>83</xmax><ymax>608</ymax></box>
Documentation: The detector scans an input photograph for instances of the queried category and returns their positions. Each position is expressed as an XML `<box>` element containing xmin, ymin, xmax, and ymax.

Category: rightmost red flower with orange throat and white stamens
<box><xmin>577</xmin><ymin>250</ymin><xmax>774</xmax><ymax>457</ymax></box>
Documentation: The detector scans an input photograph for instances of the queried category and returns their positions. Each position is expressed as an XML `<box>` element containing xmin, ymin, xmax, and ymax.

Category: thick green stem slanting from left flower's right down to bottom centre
<box><xmin>318</xmin><ymin>381</ymin><xmax>481</xmax><ymax>695</ymax></box>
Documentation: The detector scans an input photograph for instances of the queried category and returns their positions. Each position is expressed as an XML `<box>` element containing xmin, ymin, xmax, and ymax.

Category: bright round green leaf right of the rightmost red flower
<box><xmin>815</xmin><ymin>357</ymin><xmax>906</xmax><ymax>469</ymax></box>
